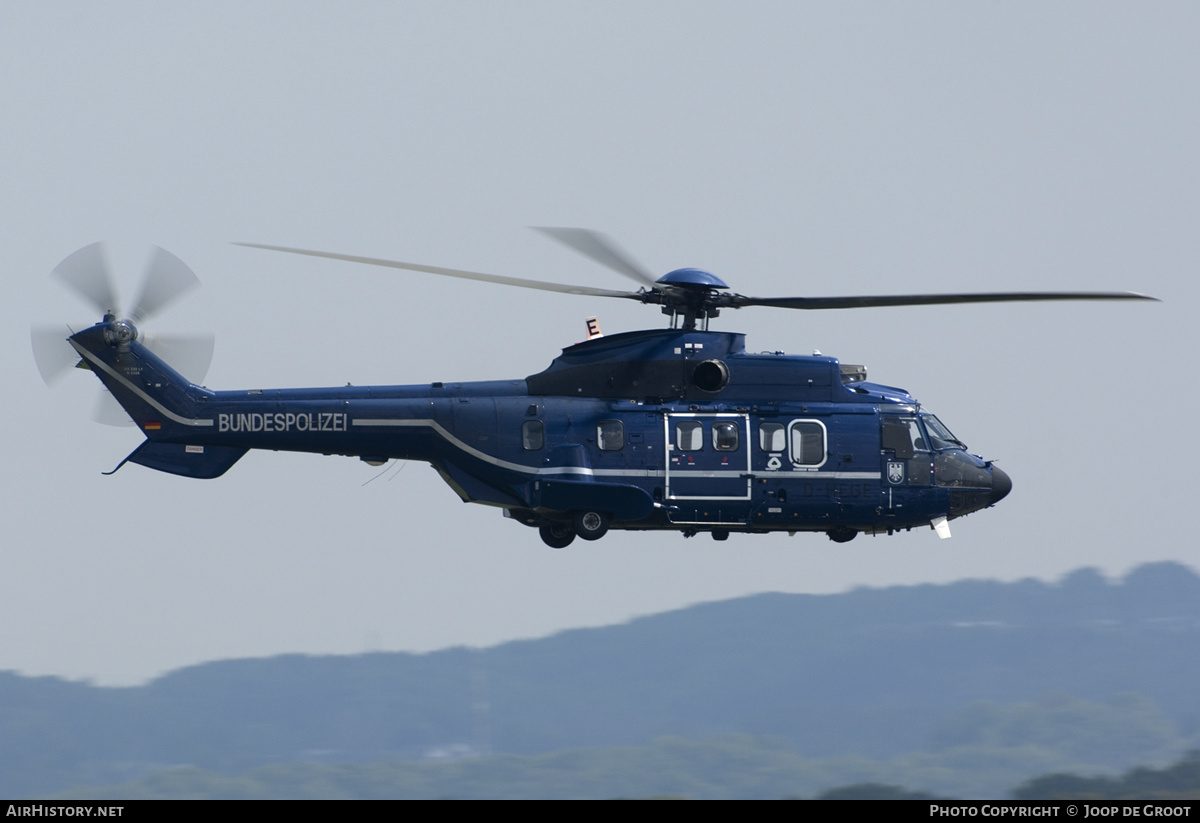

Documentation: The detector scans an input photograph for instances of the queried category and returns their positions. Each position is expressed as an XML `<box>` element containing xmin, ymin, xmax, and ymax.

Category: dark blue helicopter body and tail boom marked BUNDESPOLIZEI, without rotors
<box><xmin>72</xmin><ymin>324</ymin><xmax>1010</xmax><ymax>539</ymax></box>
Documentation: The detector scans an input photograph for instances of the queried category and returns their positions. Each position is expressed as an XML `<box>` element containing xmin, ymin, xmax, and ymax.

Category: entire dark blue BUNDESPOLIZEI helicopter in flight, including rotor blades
<box><xmin>34</xmin><ymin>228</ymin><xmax>1156</xmax><ymax>548</ymax></box>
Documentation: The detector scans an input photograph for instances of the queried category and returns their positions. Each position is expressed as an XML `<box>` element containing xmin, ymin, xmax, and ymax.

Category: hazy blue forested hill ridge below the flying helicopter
<box><xmin>0</xmin><ymin>563</ymin><xmax>1200</xmax><ymax>797</ymax></box>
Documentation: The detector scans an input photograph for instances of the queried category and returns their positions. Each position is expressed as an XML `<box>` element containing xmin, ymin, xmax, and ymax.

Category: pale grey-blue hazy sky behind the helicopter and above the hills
<box><xmin>0</xmin><ymin>0</ymin><xmax>1200</xmax><ymax>684</ymax></box>
